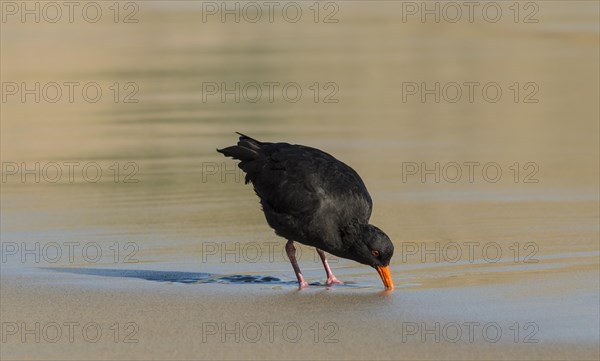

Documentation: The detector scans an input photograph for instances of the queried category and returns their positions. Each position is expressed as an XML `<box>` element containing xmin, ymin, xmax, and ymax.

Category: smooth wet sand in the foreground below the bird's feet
<box><xmin>2</xmin><ymin>270</ymin><xmax>599</xmax><ymax>360</ymax></box>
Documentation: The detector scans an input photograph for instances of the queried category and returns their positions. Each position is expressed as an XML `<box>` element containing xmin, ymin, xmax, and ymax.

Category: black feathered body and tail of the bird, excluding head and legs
<box><xmin>218</xmin><ymin>134</ymin><xmax>372</xmax><ymax>245</ymax></box>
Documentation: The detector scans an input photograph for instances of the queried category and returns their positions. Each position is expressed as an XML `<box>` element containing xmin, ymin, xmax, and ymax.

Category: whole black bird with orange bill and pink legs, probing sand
<box><xmin>217</xmin><ymin>133</ymin><xmax>394</xmax><ymax>289</ymax></box>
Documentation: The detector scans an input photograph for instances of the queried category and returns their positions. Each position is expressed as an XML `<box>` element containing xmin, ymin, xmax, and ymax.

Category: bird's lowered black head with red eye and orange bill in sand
<box><xmin>348</xmin><ymin>224</ymin><xmax>394</xmax><ymax>289</ymax></box>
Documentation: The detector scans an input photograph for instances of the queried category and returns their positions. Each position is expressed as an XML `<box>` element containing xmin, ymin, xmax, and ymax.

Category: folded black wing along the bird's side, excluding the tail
<box><xmin>251</xmin><ymin>143</ymin><xmax>373</xmax><ymax>221</ymax></box>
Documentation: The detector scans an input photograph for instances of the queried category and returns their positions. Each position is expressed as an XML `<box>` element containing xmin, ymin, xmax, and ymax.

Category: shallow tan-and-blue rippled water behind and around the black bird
<box><xmin>0</xmin><ymin>1</ymin><xmax>600</xmax><ymax>358</ymax></box>
